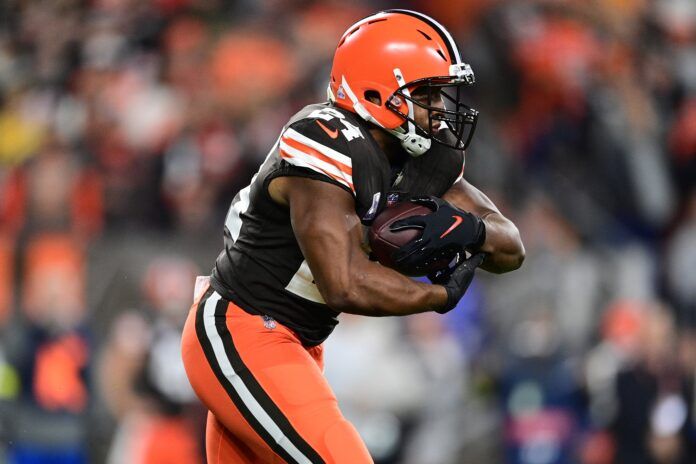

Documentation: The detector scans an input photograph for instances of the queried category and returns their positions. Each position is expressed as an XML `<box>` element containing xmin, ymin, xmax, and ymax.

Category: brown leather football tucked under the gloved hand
<box><xmin>368</xmin><ymin>201</ymin><xmax>432</xmax><ymax>275</ymax></box>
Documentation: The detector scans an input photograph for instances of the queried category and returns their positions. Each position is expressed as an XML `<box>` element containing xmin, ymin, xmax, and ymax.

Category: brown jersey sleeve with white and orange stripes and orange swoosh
<box><xmin>278</xmin><ymin>117</ymin><xmax>356</xmax><ymax>197</ymax></box>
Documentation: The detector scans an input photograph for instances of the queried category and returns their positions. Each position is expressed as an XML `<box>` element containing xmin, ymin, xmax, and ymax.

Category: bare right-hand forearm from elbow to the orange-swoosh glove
<box><xmin>481</xmin><ymin>211</ymin><xmax>525</xmax><ymax>274</ymax></box>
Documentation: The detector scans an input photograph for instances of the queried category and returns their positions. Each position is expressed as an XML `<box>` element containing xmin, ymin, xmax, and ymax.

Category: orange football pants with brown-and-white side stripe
<box><xmin>182</xmin><ymin>287</ymin><xmax>372</xmax><ymax>464</ymax></box>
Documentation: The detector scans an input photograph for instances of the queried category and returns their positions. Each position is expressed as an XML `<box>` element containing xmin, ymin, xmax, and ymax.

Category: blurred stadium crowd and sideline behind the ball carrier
<box><xmin>0</xmin><ymin>0</ymin><xmax>696</xmax><ymax>464</ymax></box>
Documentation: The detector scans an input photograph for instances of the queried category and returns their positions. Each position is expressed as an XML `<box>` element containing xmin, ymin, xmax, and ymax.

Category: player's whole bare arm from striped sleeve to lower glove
<box><xmin>269</xmin><ymin>177</ymin><xmax>448</xmax><ymax>316</ymax></box>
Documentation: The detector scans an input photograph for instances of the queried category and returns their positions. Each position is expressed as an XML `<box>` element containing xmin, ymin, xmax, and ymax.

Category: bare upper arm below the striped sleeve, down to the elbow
<box><xmin>285</xmin><ymin>177</ymin><xmax>366</xmax><ymax>305</ymax></box>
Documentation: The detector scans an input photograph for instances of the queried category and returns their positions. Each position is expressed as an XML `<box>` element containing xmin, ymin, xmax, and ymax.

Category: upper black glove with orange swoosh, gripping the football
<box><xmin>390</xmin><ymin>196</ymin><xmax>486</xmax><ymax>275</ymax></box>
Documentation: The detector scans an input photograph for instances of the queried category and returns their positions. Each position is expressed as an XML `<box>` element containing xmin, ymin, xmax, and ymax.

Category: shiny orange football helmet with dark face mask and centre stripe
<box><xmin>328</xmin><ymin>10</ymin><xmax>478</xmax><ymax>156</ymax></box>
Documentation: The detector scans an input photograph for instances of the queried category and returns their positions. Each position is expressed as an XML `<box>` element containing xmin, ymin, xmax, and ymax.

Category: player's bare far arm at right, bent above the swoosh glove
<box><xmin>443</xmin><ymin>179</ymin><xmax>525</xmax><ymax>274</ymax></box>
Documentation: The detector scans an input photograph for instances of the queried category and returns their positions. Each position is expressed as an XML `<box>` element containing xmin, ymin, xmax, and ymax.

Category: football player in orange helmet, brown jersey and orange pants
<box><xmin>182</xmin><ymin>10</ymin><xmax>524</xmax><ymax>464</ymax></box>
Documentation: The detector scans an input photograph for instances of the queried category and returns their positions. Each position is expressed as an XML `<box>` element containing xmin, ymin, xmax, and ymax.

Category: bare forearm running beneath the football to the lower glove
<box><xmin>327</xmin><ymin>262</ymin><xmax>447</xmax><ymax>316</ymax></box>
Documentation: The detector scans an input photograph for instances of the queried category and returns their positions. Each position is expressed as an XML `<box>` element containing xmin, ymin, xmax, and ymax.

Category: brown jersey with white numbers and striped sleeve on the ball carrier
<box><xmin>211</xmin><ymin>103</ymin><xmax>464</xmax><ymax>346</ymax></box>
